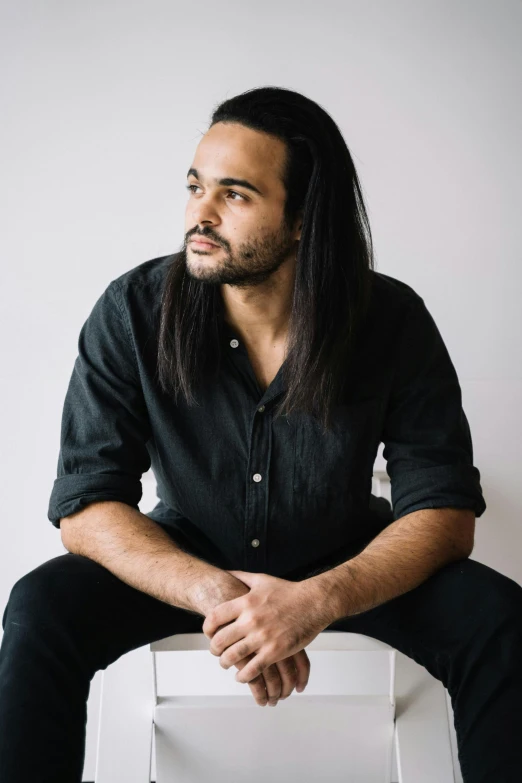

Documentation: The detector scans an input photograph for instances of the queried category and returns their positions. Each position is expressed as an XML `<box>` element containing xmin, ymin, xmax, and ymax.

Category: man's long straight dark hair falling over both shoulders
<box><xmin>157</xmin><ymin>87</ymin><xmax>374</xmax><ymax>429</ymax></box>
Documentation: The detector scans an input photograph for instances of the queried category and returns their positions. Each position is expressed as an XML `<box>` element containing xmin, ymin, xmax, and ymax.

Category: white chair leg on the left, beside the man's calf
<box><xmin>95</xmin><ymin>645</ymin><xmax>155</xmax><ymax>783</ymax></box>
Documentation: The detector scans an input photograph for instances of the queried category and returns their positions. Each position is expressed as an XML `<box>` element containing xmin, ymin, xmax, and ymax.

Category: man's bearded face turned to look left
<box><xmin>183</xmin><ymin>122</ymin><xmax>301</xmax><ymax>287</ymax></box>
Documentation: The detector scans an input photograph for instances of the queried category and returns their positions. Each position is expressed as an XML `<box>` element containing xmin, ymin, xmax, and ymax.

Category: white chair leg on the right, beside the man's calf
<box><xmin>395</xmin><ymin>652</ymin><xmax>455</xmax><ymax>783</ymax></box>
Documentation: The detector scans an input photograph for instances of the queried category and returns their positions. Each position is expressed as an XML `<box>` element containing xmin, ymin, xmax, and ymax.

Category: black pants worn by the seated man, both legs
<box><xmin>0</xmin><ymin>553</ymin><xmax>522</xmax><ymax>783</ymax></box>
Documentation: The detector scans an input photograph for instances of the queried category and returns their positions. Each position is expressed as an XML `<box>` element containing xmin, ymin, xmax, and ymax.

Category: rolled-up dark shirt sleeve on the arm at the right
<box><xmin>382</xmin><ymin>296</ymin><xmax>486</xmax><ymax>520</ymax></box>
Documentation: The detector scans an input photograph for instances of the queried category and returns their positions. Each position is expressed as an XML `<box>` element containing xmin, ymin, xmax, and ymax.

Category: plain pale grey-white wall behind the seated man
<box><xmin>0</xmin><ymin>0</ymin><xmax>522</xmax><ymax>780</ymax></box>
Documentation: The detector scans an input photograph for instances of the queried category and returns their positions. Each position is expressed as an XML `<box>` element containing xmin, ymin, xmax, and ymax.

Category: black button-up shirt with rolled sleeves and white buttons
<box><xmin>48</xmin><ymin>255</ymin><xmax>486</xmax><ymax>578</ymax></box>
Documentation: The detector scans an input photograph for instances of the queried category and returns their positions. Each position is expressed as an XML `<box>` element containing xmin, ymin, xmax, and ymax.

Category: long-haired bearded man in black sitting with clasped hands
<box><xmin>0</xmin><ymin>87</ymin><xmax>522</xmax><ymax>783</ymax></box>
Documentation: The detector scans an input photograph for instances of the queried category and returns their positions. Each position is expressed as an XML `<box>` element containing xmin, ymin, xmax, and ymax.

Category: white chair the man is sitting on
<box><xmin>95</xmin><ymin>472</ymin><xmax>458</xmax><ymax>783</ymax></box>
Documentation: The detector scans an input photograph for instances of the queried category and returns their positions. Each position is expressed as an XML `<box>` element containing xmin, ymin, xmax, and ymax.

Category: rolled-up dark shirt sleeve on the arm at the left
<box><xmin>47</xmin><ymin>281</ymin><xmax>151</xmax><ymax>527</ymax></box>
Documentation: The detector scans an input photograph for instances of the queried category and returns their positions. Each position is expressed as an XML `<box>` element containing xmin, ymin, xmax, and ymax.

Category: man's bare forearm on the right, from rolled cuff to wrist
<box><xmin>307</xmin><ymin>508</ymin><xmax>471</xmax><ymax>622</ymax></box>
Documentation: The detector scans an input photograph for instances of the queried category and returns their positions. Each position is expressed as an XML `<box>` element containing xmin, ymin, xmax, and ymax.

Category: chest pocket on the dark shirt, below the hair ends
<box><xmin>293</xmin><ymin>397</ymin><xmax>383</xmax><ymax>516</ymax></box>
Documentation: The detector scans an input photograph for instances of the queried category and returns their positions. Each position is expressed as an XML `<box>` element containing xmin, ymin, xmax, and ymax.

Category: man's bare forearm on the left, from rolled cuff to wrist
<box><xmin>60</xmin><ymin>501</ymin><xmax>241</xmax><ymax>616</ymax></box>
